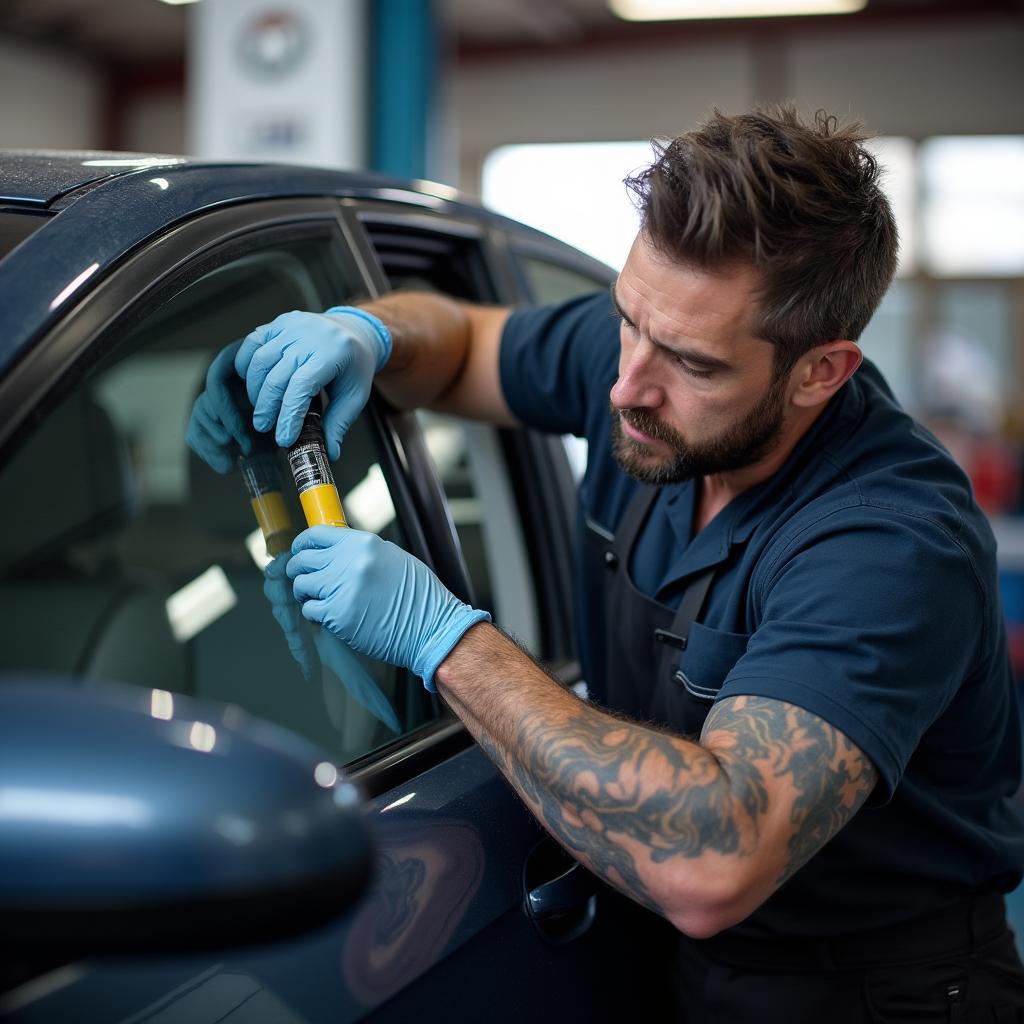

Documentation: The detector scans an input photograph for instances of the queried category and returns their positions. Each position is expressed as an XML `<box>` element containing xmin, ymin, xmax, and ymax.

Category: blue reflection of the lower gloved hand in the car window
<box><xmin>263</xmin><ymin>555</ymin><xmax>401</xmax><ymax>734</ymax></box>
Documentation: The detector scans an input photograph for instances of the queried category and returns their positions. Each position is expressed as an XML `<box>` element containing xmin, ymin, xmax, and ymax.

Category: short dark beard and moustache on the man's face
<box><xmin>611</xmin><ymin>374</ymin><xmax>788</xmax><ymax>486</ymax></box>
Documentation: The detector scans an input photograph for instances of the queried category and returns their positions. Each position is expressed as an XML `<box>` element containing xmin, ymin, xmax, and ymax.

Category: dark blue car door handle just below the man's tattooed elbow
<box><xmin>524</xmin><ymin>840</ymin><xmax>597</xmax><ymax>944</ymax></box>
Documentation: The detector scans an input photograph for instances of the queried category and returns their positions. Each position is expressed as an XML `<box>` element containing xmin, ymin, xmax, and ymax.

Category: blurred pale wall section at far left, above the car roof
<box><xmin>0</xmin><ymin>38</ymin><xmax>103</xmax><ymax>150</ymax></box>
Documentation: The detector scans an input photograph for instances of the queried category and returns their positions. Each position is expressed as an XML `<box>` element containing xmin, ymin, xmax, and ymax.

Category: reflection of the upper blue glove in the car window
<box><xmin>185</xmin><ymin>341</ymin><xmax>253</xmax><ymax>473</ymax></box>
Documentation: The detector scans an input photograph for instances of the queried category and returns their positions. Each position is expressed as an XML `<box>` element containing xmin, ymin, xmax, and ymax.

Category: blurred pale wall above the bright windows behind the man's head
<box><xmin>454</xmin><ymin>18</ymin><xmax>1024</xmax><ymax>194</ymax></box>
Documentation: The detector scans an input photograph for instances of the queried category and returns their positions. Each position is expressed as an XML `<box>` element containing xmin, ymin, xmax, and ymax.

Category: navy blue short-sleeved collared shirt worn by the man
<box><xmin>501</xmin><ymin>293</ymin><xmax>1024</xmax><ymax>935</ymax></box>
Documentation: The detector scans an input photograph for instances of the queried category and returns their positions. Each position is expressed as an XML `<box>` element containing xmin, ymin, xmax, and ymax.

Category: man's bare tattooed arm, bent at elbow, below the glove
<box><xmin>437</xmin><ymin>624</ymin><xmax>876</xmax><ymax>937</ymax></box>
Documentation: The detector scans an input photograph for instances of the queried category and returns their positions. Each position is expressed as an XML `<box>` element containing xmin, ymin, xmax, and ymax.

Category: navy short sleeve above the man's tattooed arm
<box><xmin>719</xmin><ymin>507</ymin><xmax>988</xmax><ymax>803</ymax></box>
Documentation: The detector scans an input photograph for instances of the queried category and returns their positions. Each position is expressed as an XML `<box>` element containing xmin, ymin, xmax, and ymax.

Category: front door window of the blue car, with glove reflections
<box><xmin>0</xmin><ymin>230</ymin><xmax>440</xmax><ymax>763</ymax></box>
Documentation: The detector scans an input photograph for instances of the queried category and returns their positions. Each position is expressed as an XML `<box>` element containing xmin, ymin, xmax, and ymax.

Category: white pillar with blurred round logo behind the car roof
<box><xmin>186</xmin><ymin>0</ymin><xmax>370</xmax><ymax>169</ymax></box>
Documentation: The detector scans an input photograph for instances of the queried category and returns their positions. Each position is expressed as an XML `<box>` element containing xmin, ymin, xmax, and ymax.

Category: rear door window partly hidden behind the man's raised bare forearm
<box><xmin>365</xmin><ymin>217</ymin><xmax>542</xmax><ymax>654</ymax></box>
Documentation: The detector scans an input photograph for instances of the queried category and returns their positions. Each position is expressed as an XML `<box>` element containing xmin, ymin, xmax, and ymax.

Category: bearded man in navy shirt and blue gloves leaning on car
<box><xmin>193</xmin><ymin>109</ymin><xmax>1024</xmax><ymax>1022</ymax></box>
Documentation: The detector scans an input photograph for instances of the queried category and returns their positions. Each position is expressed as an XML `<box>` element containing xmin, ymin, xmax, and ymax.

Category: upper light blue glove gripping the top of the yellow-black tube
<box><xmin>234</xmin><ymin>306</ymin><xmax>391</xmax><ymax>459</ymax></box>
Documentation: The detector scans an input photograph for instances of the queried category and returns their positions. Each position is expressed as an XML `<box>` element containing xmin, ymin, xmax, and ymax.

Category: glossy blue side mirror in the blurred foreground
<box><xmin>0</xmin><ymin>675</ymin><xmax>372</xmax><ymax>958</ymax></box>
